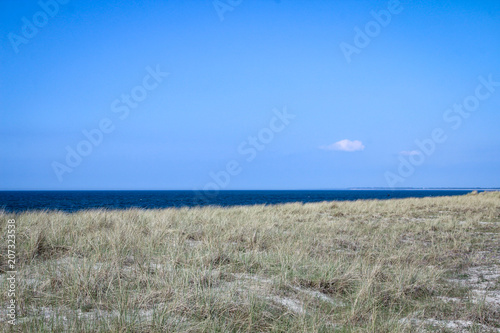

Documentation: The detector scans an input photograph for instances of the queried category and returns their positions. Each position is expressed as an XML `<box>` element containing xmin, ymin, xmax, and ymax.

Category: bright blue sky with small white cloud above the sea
<box><xmin>0</xmin><ymin>0</ymin><xmax>500</xmax><ymax>190</ymax></box>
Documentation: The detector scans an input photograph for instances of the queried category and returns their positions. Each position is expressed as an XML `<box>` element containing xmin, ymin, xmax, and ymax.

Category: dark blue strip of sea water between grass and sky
<box><xmin>0</xmin><ymin>189</ymin><xmax>480</xmax><ymax>212</ymax></box>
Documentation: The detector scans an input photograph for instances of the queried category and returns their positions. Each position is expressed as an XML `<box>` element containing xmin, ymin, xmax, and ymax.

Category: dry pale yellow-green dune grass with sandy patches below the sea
<box><xmin>0</xmin><ymin>192</ymin><xmax>500</xmax><ymax>332</ymax></box>
